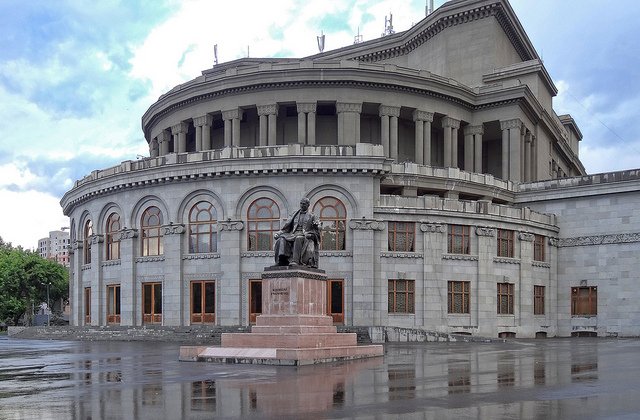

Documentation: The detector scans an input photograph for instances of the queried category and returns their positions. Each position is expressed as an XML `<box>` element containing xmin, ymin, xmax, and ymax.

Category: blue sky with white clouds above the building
<box><xmin>0</xmin><ymin>0</ymin><xmax>640</xmax><ymax>248</ymax></box>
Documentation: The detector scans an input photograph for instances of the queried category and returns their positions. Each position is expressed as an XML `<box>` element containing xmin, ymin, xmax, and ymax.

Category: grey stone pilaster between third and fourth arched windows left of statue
<box><xmin>118</xmin><ymin>227</ymin><xmax>141</xmax><ymax>326</ymax></box>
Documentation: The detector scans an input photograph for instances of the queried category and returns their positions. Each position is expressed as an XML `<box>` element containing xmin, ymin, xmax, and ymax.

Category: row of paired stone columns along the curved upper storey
<box><xmin>149</xmin><ymin>102</ymin><xmax>537</xmax><ymax>182</ymax></box>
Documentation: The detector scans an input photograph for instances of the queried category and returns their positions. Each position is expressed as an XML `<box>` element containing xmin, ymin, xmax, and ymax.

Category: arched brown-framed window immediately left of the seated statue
<box><xmin>247</xmin><ymin>198</ymin><xmax>280</xmax><ymax>251</ymax></box>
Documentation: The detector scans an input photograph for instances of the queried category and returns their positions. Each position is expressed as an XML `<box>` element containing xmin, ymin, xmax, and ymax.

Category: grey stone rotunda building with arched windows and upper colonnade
<box><xmin>61</xmin><ymin>0</ymin><xmax>640</xmax><ymax>337</ymax></box>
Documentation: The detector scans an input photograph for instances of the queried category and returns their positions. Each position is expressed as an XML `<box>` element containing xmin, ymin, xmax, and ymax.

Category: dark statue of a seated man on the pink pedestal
<box><xmin>273</xmin><ymin>197</ymin><xmax>322</xmax><ymax>268</ymax></box>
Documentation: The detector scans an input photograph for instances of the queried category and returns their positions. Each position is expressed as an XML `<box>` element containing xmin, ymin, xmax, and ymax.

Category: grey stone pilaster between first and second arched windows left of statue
<box><xmin>216</xmin><ymin>219</ymin><xmax>244</xmax><ymax>325</ymax></box>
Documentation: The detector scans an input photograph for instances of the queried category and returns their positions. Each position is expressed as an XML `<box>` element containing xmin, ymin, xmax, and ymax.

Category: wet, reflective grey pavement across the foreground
<box><xmin>0</xmin><ymin>336</ymin><xmax>640</xmax><ymax>420</ymax></box>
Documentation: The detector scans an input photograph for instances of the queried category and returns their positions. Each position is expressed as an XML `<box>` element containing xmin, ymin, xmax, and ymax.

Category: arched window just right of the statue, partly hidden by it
<box><xmin>313</xmin><ymin>197</ymin><xmax>347</xmax><ymax>251</ymax></box>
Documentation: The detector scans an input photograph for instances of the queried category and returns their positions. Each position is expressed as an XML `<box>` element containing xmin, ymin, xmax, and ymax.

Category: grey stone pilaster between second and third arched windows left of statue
<box><xmin>160</xmin><ymin>223</ymin><xmax>188</xmax><ymax>326</ymax></box>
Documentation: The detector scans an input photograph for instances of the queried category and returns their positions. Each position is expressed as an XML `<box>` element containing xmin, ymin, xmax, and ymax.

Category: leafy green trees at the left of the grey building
<box><xmin>0</xmin><ymin>238</ymin><xmax>69</xmax><ymax>325</ymax></box>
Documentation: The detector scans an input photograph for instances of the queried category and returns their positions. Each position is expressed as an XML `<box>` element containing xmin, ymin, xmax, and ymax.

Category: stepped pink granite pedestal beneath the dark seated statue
<box><xmin>180</xmin><ymin>267</ymin><xmax>383</xmax><ymax>366</ymax></box>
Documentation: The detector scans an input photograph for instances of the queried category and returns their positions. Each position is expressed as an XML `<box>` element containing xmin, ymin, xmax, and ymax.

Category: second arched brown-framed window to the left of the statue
<box><xmin>189</xmin><ymin>201</ymin><xmax>218</xmax><ymax>254</ymax></box>
